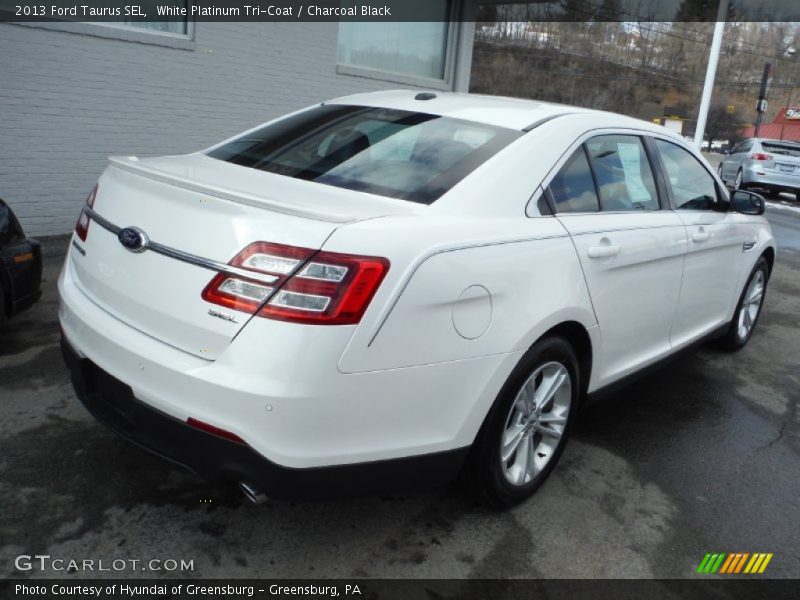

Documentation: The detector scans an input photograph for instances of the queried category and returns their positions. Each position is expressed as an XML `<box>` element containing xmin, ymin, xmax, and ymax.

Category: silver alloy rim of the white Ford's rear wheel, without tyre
<box><xmin>499</xmin><ymin>362</ymin><xmax>572</xmax><ymax>486</ymax></box>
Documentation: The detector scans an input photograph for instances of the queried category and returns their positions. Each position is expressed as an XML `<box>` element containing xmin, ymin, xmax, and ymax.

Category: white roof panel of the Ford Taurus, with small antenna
<box><xmin>329</xmin><ymin>90</ymin><xmax>646</xmax><ymax>130</ymax></box>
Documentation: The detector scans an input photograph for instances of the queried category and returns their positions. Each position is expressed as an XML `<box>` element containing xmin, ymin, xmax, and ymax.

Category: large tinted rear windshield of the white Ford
<box><xmin>208</xmin><ymin>104</ymin><xmax>522</xmax><ymax>204</ymax></box>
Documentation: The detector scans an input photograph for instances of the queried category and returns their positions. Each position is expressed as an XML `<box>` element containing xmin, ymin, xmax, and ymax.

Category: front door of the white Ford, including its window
<box><xmin>654</xmin><ymin>139</ymin><xmax>752</xmax><ymax>347</ymax></box>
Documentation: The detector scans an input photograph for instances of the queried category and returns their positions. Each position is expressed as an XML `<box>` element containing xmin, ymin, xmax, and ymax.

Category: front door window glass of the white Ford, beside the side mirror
<box><xmin>656</xmin><ymin>140</ymin><xmax>718</xmax><ymax>210</ymax></box>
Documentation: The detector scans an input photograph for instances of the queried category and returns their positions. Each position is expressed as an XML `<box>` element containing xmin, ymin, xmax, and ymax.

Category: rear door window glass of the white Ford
<box><xmin>586</xmin><ymin>135</ymin><xmax>659</xmax><ymax>211</ymax></box>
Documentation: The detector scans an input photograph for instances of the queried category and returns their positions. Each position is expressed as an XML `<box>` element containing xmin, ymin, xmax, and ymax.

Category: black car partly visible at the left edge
<box><xmin>0</xmin><ymin>200</ymin><xmax>42</xmax><ymax>328</ymax></box>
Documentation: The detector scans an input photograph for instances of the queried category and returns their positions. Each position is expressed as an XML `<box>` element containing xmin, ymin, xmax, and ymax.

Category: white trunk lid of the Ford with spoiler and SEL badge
<box><xmin>68</xmin><ymin>154</ymin><xmax>414</xmax><ymax>360</ymax></box>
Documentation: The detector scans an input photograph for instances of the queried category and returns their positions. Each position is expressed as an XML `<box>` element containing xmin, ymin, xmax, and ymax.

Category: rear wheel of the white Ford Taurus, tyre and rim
<box><xmin>470</xmin><ymin>337</ymin><xmax>580</xmax><ymax>508</ymax></box>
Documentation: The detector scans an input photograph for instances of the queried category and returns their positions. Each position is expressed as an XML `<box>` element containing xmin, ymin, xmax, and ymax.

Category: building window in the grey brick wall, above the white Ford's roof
<box><xmin>338</xmin><ymin>0</ymin><xmax>450</xmax><ymax>80</ymax></box>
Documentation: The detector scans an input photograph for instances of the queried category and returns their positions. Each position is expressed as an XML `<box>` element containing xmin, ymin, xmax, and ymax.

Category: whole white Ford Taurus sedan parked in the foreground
<box><xmin>59</xmin><ymin>91</ymin><xmax>775</xmax><ymax>506</ymax></box>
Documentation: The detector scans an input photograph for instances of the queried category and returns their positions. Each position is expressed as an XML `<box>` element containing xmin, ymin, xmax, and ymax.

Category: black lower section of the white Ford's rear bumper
<box><xmin>61</xmin><ymin>337</ymin><xmax>469</xmax><ymax>498</ymax></box>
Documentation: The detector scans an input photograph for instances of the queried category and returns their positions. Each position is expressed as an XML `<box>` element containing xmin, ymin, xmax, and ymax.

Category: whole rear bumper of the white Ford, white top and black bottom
<box><xmin>59</xmin><ymin>250</ymin><xmax>520</xmax><ymax>495</ymax></box>
